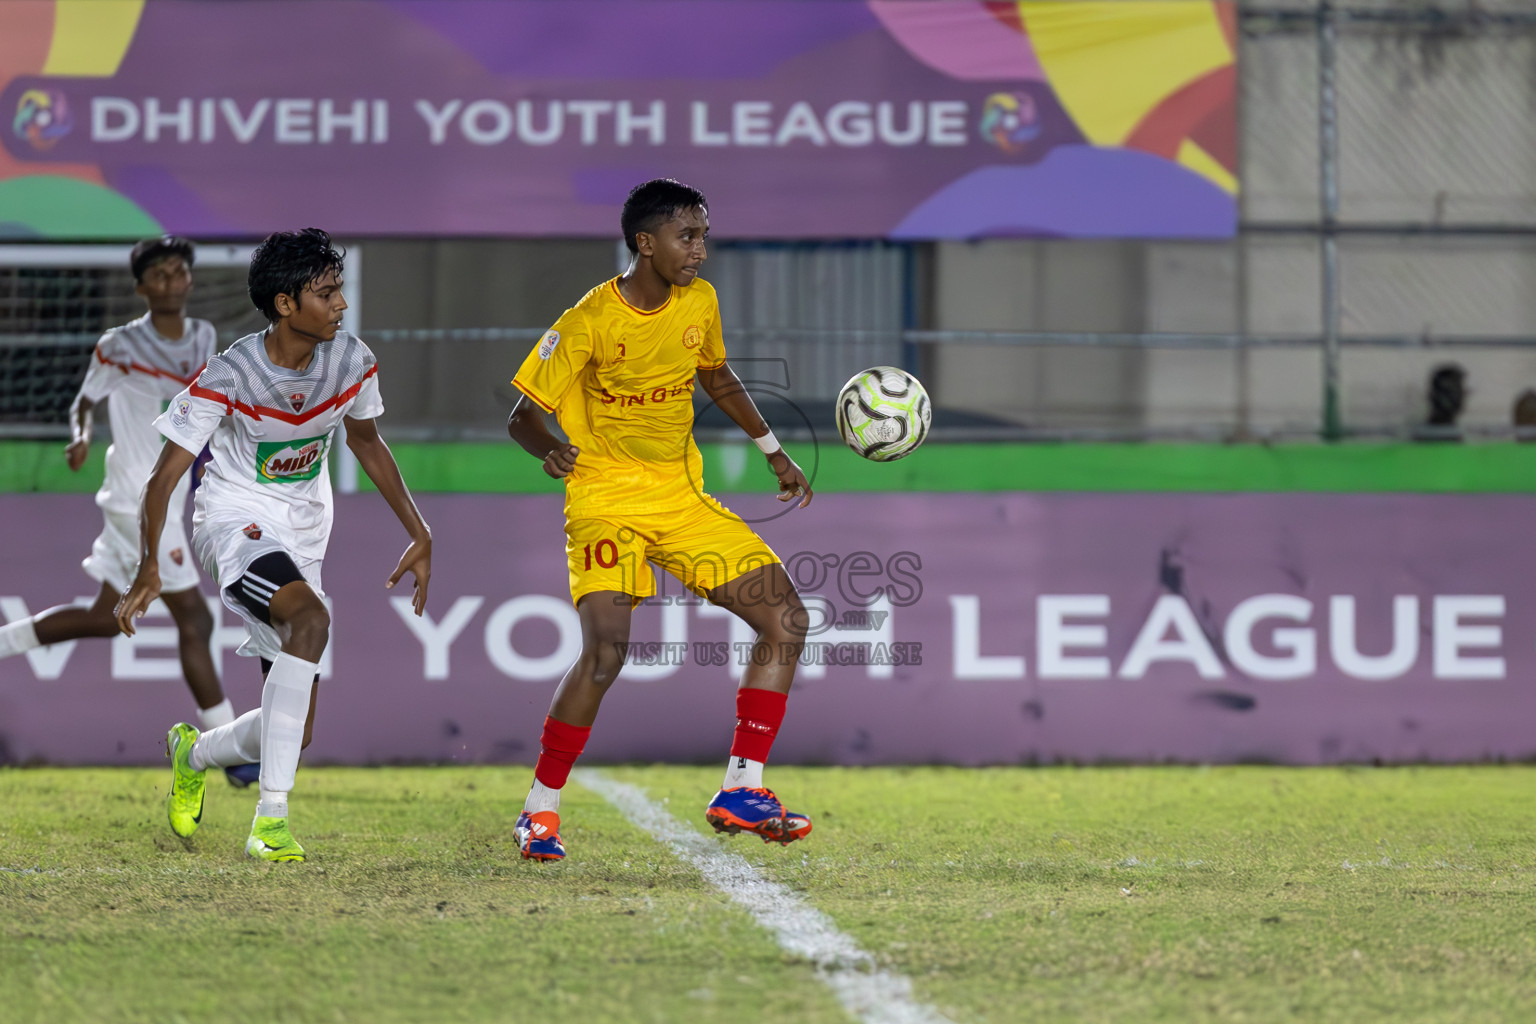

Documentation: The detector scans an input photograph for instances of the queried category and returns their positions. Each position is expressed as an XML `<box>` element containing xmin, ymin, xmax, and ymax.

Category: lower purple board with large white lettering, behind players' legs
<box><xmin>0</xmin><ymin>493</ymin><xmax>1536</xmax><ymax>765</ymax></box>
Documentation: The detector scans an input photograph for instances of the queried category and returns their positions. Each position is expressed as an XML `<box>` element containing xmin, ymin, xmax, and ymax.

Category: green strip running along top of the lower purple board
<box><xmin>9</xmin><ymin>441</ymin><xmax>1536</xmax><ymax>494</ymax></box>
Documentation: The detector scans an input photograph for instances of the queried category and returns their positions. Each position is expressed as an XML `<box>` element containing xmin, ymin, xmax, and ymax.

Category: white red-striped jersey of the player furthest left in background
<box><xmin>80</xmin><ymin>313</ymin><xmax>217</xmax><ymax>516</ymax></box>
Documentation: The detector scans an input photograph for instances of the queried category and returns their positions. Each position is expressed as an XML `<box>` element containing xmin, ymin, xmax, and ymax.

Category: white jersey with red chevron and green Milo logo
<box><xmin>155</xmin><ymin>332</ymin><xmax>384</xmax><ymax>563</ymax></box>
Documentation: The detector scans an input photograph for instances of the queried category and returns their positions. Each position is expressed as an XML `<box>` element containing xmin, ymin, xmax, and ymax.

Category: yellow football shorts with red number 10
<box><xmin>565</xmin><ymin>494</ymin><xmax>779</xmax><ymax>602</ymax></box>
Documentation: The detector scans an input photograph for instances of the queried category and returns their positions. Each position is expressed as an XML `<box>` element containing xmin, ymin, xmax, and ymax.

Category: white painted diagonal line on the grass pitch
<box><xmin>576</xmin><ymin>769</ymin><xmax>952</xmax><ymax>1024</ymax></box>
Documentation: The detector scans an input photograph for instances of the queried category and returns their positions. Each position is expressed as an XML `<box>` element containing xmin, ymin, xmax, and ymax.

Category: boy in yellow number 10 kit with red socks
<box><xmin>507</xmin><ymin>178</ymin><xmax>811</xmax><ymax>860</ymax></box>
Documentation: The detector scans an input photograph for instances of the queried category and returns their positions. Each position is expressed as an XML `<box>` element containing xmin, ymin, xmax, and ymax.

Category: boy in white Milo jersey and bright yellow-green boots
<box><xmin>117</xmin><ymin>227</ymin><xmax>432</xmax><ymax>861</ymax></box>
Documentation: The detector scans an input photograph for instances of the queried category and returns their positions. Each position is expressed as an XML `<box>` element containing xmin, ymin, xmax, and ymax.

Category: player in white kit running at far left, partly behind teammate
<box><xmin>0</xmin><ymin>235</ymin><xmax>255</xmax><ymax>786</ymax></box>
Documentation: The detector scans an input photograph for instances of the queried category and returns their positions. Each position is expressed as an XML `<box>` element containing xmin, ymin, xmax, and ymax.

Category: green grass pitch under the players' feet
<box><xmin>0</xmin><ymin>766</ymin><xmax>1536</xmax><ymax>1024</ymax></box>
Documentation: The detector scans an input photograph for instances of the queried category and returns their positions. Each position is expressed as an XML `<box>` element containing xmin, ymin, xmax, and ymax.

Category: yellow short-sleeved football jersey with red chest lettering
<box><xmin>511</xmin><ymin>278</ymin><xmax>725</xmax><ymax>517</ymax></box>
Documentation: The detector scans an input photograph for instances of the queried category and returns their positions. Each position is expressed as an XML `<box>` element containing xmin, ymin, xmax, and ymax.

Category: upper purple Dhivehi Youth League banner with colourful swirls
<box><xmin>0</xmin><ymin>0</ymin><xmax>1238</xmax><ymax>238</ymax></box>
